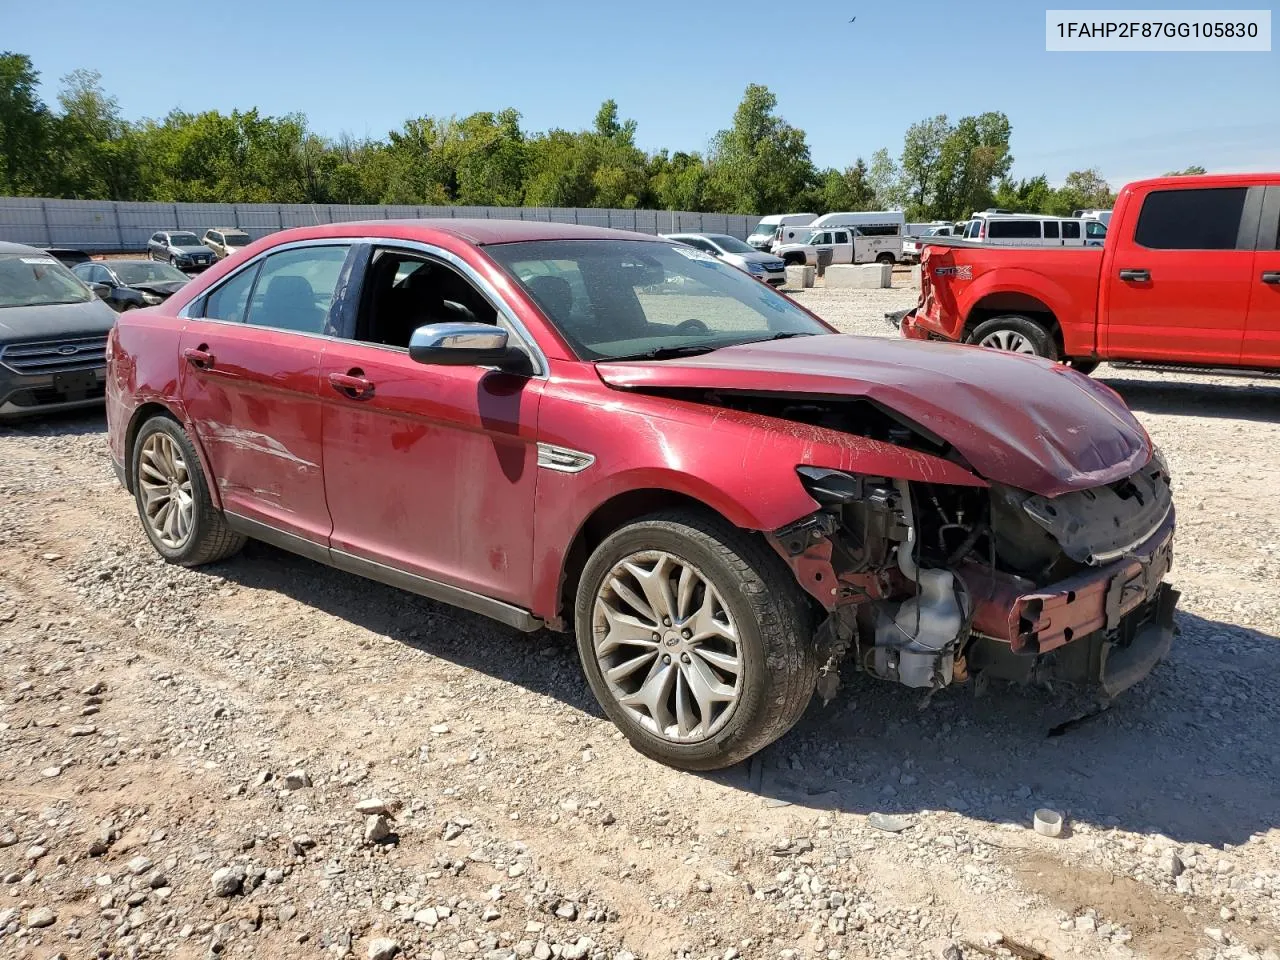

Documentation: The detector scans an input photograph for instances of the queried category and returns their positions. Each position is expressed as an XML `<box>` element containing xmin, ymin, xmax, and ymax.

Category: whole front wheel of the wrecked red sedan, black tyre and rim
<box><xmin>575</xmin><ymin>511</ymin><xmax>818</xmax><ymax>771</ymax></box>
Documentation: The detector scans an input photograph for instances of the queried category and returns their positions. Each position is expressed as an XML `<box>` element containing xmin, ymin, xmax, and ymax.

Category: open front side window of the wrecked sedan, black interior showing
<box><xmin>358</xmin><ymin>250</ymin><xmax>498</xmax><ymax>348</ymax></box>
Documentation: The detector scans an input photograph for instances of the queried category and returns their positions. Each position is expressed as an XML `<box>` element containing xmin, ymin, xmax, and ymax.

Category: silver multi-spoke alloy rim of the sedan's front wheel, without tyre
<box><xmin>593</xmin><ymin>550</ymin><xmax>744</xmax><ymax>744</ymax></box>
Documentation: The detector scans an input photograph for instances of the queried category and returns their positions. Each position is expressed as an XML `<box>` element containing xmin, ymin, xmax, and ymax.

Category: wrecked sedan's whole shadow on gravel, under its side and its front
<box><xmin>209</xmin><ymin>543</ymin><xmax>1280</xmax><ymax>846</ymax></box>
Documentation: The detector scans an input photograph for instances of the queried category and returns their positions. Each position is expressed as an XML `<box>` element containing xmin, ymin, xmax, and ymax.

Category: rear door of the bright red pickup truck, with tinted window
<box><xmin>1100</xmin><ymin>187</ymin><xmax>1262</xmax><ymax>365</ymax></box>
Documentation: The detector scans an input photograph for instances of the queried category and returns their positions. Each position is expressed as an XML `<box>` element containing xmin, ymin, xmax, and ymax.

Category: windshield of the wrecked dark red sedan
<box><xmin>485</xmin><ymin>241</ymin><xmax>832</xmax><ymax>360</ymax></box>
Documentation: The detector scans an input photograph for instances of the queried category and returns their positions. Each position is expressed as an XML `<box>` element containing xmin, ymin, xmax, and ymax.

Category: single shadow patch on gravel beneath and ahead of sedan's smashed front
<box><xmin>712</xmin><ymin>614</ymin><xmax>1280</xmax><ymax>846</ymax></box>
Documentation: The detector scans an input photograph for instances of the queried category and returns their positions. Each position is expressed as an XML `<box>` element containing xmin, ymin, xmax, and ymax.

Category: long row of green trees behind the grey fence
<box><xmin>0</xmin><ymin>52</ymin><xmax>1203</xmax><ymax>220</ymax></box>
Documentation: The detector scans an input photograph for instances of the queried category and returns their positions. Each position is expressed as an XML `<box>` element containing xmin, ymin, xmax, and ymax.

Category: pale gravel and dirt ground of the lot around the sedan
<box><xmin>0</xmin><ymin>289</ymin><xmax>1280</xmax><ymax>960</ymax></box>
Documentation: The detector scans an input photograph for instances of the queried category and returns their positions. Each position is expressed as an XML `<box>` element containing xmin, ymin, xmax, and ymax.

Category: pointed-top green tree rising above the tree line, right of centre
<box><xmin>708</xmin><ymin>83</ymin><xmax>815</xmax><ymax>214</ymax></box>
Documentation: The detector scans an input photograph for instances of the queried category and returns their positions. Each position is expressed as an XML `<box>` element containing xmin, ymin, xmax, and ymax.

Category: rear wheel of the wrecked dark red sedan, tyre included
<box><xmin>132</xmin><ymin>416</ymin><xmax>244</xmax><ymax>567</ymax></box>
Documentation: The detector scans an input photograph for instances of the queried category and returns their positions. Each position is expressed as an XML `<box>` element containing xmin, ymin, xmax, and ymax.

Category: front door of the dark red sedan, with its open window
<box><xmin>320</xmin><ymin>246</ymin><xmax>544</xmax><ymax>608</ymax></box>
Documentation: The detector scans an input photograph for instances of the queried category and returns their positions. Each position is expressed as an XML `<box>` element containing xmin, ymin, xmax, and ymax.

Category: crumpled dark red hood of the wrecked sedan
<box><xmin>595</xmin><ymin>334</ymin><xmax>1151</xmax><ymax>497</ymax></box>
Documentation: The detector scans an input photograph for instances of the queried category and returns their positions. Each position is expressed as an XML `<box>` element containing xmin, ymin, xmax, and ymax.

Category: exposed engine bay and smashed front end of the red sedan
<box><xmin>707</xmin><ymin>394</ymin><xmax>1178</xmax><ymax>696</ymax></box>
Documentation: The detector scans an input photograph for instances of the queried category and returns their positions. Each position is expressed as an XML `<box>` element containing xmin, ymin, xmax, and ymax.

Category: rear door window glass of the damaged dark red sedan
<box><xmin>247</xmin><ymin>244</ymin><xmax>348</xmax><ymax>333</ymax></box>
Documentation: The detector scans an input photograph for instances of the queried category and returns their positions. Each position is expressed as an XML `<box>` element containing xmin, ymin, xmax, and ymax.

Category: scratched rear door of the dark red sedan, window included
<box><xmin>180</xmin><ymin>244</ymin><xmax>349</xmax><ymax>544</ymax></box>
